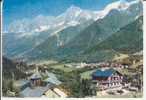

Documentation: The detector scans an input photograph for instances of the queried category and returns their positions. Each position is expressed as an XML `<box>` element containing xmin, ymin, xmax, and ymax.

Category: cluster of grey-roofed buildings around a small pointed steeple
<box><xmin>16</xmin><ymin>68</ymin><xmax>67</xmax><ymax>98</ymax></box>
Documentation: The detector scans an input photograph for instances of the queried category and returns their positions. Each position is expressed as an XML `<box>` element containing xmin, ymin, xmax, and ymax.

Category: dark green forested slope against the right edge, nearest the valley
<box><xmin>84</xmin><ymin>16</ymin><xmax>143</xmax><ymax>61</ymax></box>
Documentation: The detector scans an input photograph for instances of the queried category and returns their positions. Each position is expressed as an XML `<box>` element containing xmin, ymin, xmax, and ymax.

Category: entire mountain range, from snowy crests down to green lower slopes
<box><xmin>3</xmin><ymin>0</ymin><xmax>143</xmax><ymax>61</ymax></box>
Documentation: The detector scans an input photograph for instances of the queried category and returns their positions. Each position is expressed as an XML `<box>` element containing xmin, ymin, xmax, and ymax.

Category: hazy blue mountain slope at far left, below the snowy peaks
<box><xmin>2</xmin><ymin>31</ymin><xmax>49</xmax><ymax>58</ymax></box>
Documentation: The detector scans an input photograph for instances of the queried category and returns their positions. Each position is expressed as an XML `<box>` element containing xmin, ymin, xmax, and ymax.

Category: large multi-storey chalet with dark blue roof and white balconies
<box><xmin>92</xmin><ymin>69</ymin><xmax>123</xmax><ymax>90</ymax></box>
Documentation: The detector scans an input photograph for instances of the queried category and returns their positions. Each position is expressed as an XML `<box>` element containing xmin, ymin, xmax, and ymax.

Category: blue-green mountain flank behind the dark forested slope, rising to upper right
<box><xmin>61</xmin><ymin>2</ymin><xmax>142</xmax><ymax>54</ymax></box>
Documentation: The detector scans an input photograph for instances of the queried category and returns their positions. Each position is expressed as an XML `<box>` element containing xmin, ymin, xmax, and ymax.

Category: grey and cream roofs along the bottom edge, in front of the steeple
<box><xmin>19</xmin><ymin>84</ymin><xmax>67</xmax><ymax>98</ymax></box>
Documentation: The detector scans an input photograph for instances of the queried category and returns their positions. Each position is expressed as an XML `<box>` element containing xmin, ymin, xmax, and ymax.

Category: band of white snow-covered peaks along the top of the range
<box><xmin>7</xmin><ymin>0</ymin><xmax>140</xmax><ymax>35</ymax></box>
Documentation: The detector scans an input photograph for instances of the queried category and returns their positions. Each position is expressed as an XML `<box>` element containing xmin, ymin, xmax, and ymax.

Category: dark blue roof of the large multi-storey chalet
<box><xmin>92</xmin><ymin>69</ymin><xmax>120</xmax><ymax>77</ymax></box>
